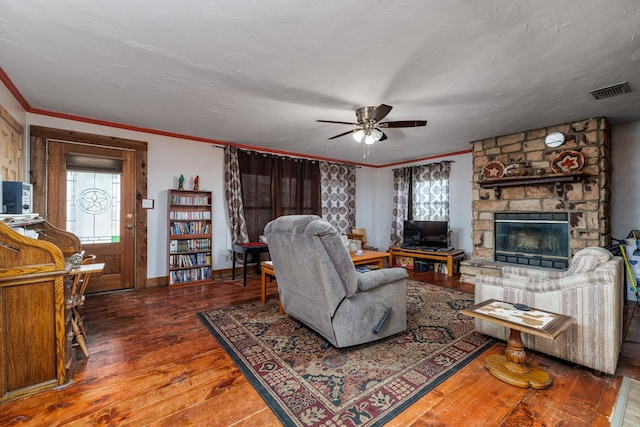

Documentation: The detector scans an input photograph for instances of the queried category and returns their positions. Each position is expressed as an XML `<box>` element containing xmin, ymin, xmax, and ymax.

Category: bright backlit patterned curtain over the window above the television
<box><xmin>410</xmin><ymin>161</ymin><xmax>451</xmax><ymax>221</ymax></box>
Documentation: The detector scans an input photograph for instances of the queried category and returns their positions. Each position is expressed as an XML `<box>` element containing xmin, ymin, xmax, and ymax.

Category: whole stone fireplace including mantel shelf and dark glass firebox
<box><xmin>460</xmin><ymin>118</ymin><xmax>611</xmax><ymax>283</ymax></box>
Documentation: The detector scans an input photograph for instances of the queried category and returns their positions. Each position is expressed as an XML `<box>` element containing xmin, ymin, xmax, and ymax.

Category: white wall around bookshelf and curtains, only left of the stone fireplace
<box><xmin>0</xmin><ymin>78</ymin><xmax>478</xmax><ymax>278</ymax></box>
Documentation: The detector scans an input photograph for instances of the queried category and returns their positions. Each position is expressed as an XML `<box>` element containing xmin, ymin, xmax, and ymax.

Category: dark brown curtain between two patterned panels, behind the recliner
<box><xmin>238</xmin><ymin>150</ymin><xmax>321</xmax><ymax>242</ymax></box>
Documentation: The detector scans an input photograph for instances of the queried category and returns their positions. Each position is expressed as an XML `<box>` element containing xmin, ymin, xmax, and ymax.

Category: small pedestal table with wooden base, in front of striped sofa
<box><xmin>460</xmin><ymin>299</ymin><xmax>573</xmax><ymax>390</ymax></box>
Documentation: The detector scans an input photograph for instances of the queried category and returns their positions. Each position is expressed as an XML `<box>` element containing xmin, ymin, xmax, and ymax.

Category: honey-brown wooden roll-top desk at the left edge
<box><xmin>0</xmin><ymin>221</ymin><xmax>79</xmax><ymax>402</ymax></box>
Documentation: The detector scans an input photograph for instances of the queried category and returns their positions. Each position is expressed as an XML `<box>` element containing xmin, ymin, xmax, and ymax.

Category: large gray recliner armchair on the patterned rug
<box><xmin>264</xmin><ymin>215</ymin><xmax>408</xmax><ymax>347</ymax></box>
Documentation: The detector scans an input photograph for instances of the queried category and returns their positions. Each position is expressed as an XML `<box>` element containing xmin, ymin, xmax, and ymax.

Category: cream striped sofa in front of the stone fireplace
<box><xmin>475</xmin><ymin>247</ymin><xmax>624</xmax><ymax>374</ymax></box>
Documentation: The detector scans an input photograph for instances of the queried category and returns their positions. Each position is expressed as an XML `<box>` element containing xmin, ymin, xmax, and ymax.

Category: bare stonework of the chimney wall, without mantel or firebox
<box><xmin>468</xmin><ymin>118</ymin><xmax>611</xmax><ymax>268</ymax></box>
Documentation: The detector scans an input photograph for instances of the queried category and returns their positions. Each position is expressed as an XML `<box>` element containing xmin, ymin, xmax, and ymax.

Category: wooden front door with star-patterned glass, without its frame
<box><xmin>47</xmin><ymin>140</ymin><xmax>136</xmax><ymax>292</ymax></box>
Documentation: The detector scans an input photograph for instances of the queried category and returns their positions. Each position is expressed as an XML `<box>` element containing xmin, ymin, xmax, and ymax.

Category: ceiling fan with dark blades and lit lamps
<box><xmin>316</xmin><ymin>104</ymin><xmax>427</xmax><ymax>145</ymax></box>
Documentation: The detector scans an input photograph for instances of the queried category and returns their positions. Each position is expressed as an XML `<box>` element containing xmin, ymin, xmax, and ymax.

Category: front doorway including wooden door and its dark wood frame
<box><xmin>31</xmin><ymin>127</ymin><xmax>146</xmax><ymax>293</ymax></box>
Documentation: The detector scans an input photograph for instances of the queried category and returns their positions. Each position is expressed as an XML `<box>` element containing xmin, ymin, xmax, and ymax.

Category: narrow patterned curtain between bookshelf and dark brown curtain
<box><xmin>224</xmin><ymin>146</ymin><xmax>249</xmax><ymax>243</ymax></box>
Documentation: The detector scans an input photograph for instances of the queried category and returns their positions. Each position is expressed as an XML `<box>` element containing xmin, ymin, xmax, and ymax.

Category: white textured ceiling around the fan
<box><xmin>0</xmin><ymin>0</ymin><xmax>640</xmax><ymax>165</ymax></box>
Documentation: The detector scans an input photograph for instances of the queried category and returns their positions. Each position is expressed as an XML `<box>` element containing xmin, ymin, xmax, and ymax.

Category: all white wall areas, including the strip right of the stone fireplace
<box><xmin>0</xmin><ymin>79</ymin><xmax>640</xmax><ymax>278</ymax></box>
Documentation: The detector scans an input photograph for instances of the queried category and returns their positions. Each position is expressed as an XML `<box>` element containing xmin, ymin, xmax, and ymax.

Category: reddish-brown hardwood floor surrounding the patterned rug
<box><xmin>0</xmin><ymin>272</ymin><xmax>640</xmax><ymax>426</ymax></box>
